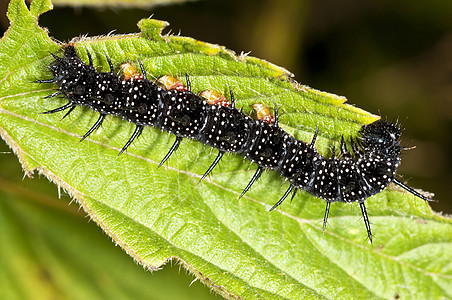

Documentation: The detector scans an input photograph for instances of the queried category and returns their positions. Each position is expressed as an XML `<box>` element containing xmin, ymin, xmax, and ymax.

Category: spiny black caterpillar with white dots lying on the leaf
<box><xmin>36</xmin><ymin>44</ymin><xmax>431</xmax><ymax>242</ymax></box>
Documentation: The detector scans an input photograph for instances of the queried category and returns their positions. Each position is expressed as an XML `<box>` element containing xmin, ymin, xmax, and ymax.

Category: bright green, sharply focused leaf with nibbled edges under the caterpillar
<box><xmin>0</xmin><ymin>0</ymin><xmax>452</xmax><ymax>299</ymax></box>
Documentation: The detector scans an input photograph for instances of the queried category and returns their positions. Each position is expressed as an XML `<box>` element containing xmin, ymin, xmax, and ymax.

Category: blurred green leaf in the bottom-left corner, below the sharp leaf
<box><xmin>0</xmin><ymin>141</ymin><xmax>219</xmax><ymax>300</ymax></box>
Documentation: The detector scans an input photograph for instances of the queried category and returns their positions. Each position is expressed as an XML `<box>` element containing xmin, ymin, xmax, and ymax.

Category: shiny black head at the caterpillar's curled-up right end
<box><xmin>360</xmin><ymin>120</ymin><xmax>401</xmax><ymax>156</ymax></box>
